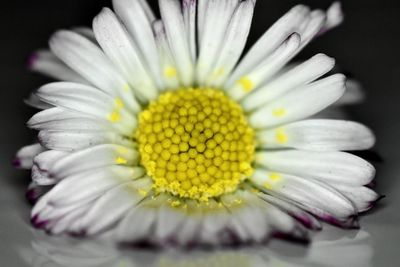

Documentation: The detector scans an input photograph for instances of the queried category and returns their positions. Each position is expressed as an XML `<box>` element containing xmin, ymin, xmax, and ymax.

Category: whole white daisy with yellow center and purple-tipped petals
<box><xmin>15</xmin><ymin>0</ymin><xmax>377</xmax><ymax>246</ymax></box>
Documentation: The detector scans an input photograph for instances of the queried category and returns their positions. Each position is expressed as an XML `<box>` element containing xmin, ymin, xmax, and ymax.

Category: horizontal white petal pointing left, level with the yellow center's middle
<box><xmin>38</xmin><ymin>130</ymin><xmax>134</xmax><ymax>152</ymax></box>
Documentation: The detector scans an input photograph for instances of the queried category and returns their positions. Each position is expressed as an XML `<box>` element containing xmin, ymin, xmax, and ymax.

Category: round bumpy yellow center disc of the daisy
<box><xmin>136</xmin><ymin>88</ymin><xmax>255</xmax><ymax>201</ymax></box>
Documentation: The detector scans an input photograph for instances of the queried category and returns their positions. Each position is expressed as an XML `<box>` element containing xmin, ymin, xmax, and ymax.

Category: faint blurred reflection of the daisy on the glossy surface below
<box><xmin>24</xmin><ymin>228</ymin><xmax>373</xmax><ymax>267</ymax></box>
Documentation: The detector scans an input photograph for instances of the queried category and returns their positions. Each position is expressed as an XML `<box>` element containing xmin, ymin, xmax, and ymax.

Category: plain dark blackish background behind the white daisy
<box><xmin>0</xmin><ymin>0</ymin><xmax>400</xmax><ymax>264</ymax></box>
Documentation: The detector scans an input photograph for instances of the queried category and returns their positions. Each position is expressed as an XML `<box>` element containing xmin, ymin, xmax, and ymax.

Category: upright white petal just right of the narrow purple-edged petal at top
<box><xmin>196</xmin><ymin>0</ymin><xmax>238</xmax><ymax>84</ymax></box>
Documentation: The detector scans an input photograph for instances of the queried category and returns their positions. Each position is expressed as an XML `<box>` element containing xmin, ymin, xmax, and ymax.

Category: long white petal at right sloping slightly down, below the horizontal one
<box><xmin>256</xmin><ymin>150</ymin><xmax>375</xmax><ymax>186</ymax></box>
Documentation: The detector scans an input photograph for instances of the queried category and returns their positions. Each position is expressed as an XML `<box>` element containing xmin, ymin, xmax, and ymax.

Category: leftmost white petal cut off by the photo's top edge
<box><xmin>113</xmin><ymin>0</ymin><xmax>163</xmax><ymax>89</ymax></box>
